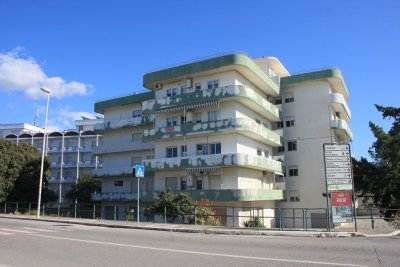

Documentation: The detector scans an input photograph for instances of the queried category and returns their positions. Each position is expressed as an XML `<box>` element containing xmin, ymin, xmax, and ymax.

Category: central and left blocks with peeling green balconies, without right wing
<box><xmin>93</xmin><ymin>54</ymin><xmax>288</xmax><ymax>227</ymax></box>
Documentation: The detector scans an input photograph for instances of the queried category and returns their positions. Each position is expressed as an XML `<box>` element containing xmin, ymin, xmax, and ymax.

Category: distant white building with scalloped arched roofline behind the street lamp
<box><xmin>0</xmin><ymin>119</ymin><xmax>103</xmax><ymax>203</ymax></box>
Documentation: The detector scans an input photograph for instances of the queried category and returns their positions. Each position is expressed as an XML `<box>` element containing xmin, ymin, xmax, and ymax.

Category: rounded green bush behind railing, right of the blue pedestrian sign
<box><xmin>144</xmin><ymin>190</ymin><xmax>194</xmax><ymax>222</ymax></box>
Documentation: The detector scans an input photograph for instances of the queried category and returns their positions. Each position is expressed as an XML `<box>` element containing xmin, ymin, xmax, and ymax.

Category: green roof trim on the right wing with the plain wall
<box><xmin>281</xmin><ymin>68</ymin><xmax>349</xmax><ymax>98</ymax></box>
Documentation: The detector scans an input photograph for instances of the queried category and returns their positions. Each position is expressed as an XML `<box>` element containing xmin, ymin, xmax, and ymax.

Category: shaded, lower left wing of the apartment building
<box><xmin>92</xmin><ymin>92</ymin><xmax>154</xmax><ymax>220</ymax></box>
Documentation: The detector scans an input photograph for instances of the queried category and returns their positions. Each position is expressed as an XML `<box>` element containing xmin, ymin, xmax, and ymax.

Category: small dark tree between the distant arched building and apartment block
<box><xmin>65</xmin><ymin>174</ymin><xmax>101</xmax><ymax>203</ymax></box>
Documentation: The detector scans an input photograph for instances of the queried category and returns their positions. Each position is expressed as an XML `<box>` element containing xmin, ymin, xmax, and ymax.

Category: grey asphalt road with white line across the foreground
<box><xmin>0</xmin><ymin>218</ymin><xmax>400</xmax><ymax>267</ymax></box>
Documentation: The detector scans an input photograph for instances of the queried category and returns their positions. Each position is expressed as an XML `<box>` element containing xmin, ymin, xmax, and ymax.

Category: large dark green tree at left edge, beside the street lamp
<box><xmin>0</xmin><ymin>139</ymin><xmax>54</xmax><ymax>202</ymax></box>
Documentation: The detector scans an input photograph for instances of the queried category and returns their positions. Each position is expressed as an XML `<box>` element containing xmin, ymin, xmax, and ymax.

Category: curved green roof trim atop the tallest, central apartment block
<box><xmin>143</xmin><ymin>54</ymin><xmax>279</xmax><ymax>93</ymax></box>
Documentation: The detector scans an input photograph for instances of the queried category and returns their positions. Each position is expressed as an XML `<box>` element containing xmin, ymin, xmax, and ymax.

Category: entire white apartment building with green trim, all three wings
<box><xmin>93</xmin><ymin>54</ymin><xmax>352</xmax><ymax>227</ymax></box>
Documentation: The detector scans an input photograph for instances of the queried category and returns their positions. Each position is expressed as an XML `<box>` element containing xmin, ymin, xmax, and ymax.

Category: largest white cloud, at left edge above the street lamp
<box><xmin>0</xmin><ymin>47</ymin><xmax>93</xmax><ymax>99</ymax></box>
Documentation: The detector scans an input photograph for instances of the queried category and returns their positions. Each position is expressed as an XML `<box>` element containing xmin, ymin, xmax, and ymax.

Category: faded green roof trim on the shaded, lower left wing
<box><xmin>94</xmin><ymin>91</ymin><xmax>154</xmax><ymax>113</ymax></box>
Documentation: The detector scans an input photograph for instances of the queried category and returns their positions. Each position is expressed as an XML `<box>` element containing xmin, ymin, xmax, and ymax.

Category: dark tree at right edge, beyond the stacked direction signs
<box><xmin>353</xmin><ymin>105</ymin><xmax>400</xmax><ymax>216</ymax></box>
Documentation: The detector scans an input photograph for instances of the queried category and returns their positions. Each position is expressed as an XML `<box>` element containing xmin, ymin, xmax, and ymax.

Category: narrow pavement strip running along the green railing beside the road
<box><xmin>0</xmin><ymin>214</ymin><xmax>400</xmax><ymax>238</ymax></box>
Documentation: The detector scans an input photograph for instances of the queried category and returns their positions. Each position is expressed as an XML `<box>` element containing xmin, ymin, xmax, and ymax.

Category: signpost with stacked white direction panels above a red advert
<box><xmin>323</xmin><ymin>144</ymin><xmax>353</xmax><ymax>230</ymax></box>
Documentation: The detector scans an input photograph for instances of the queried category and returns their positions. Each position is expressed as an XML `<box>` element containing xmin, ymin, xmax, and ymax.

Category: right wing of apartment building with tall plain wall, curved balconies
<box><xmin>275</xmin><ymin>68</ymin><xmax>353</xmax><ymax>227</ymax></box>
